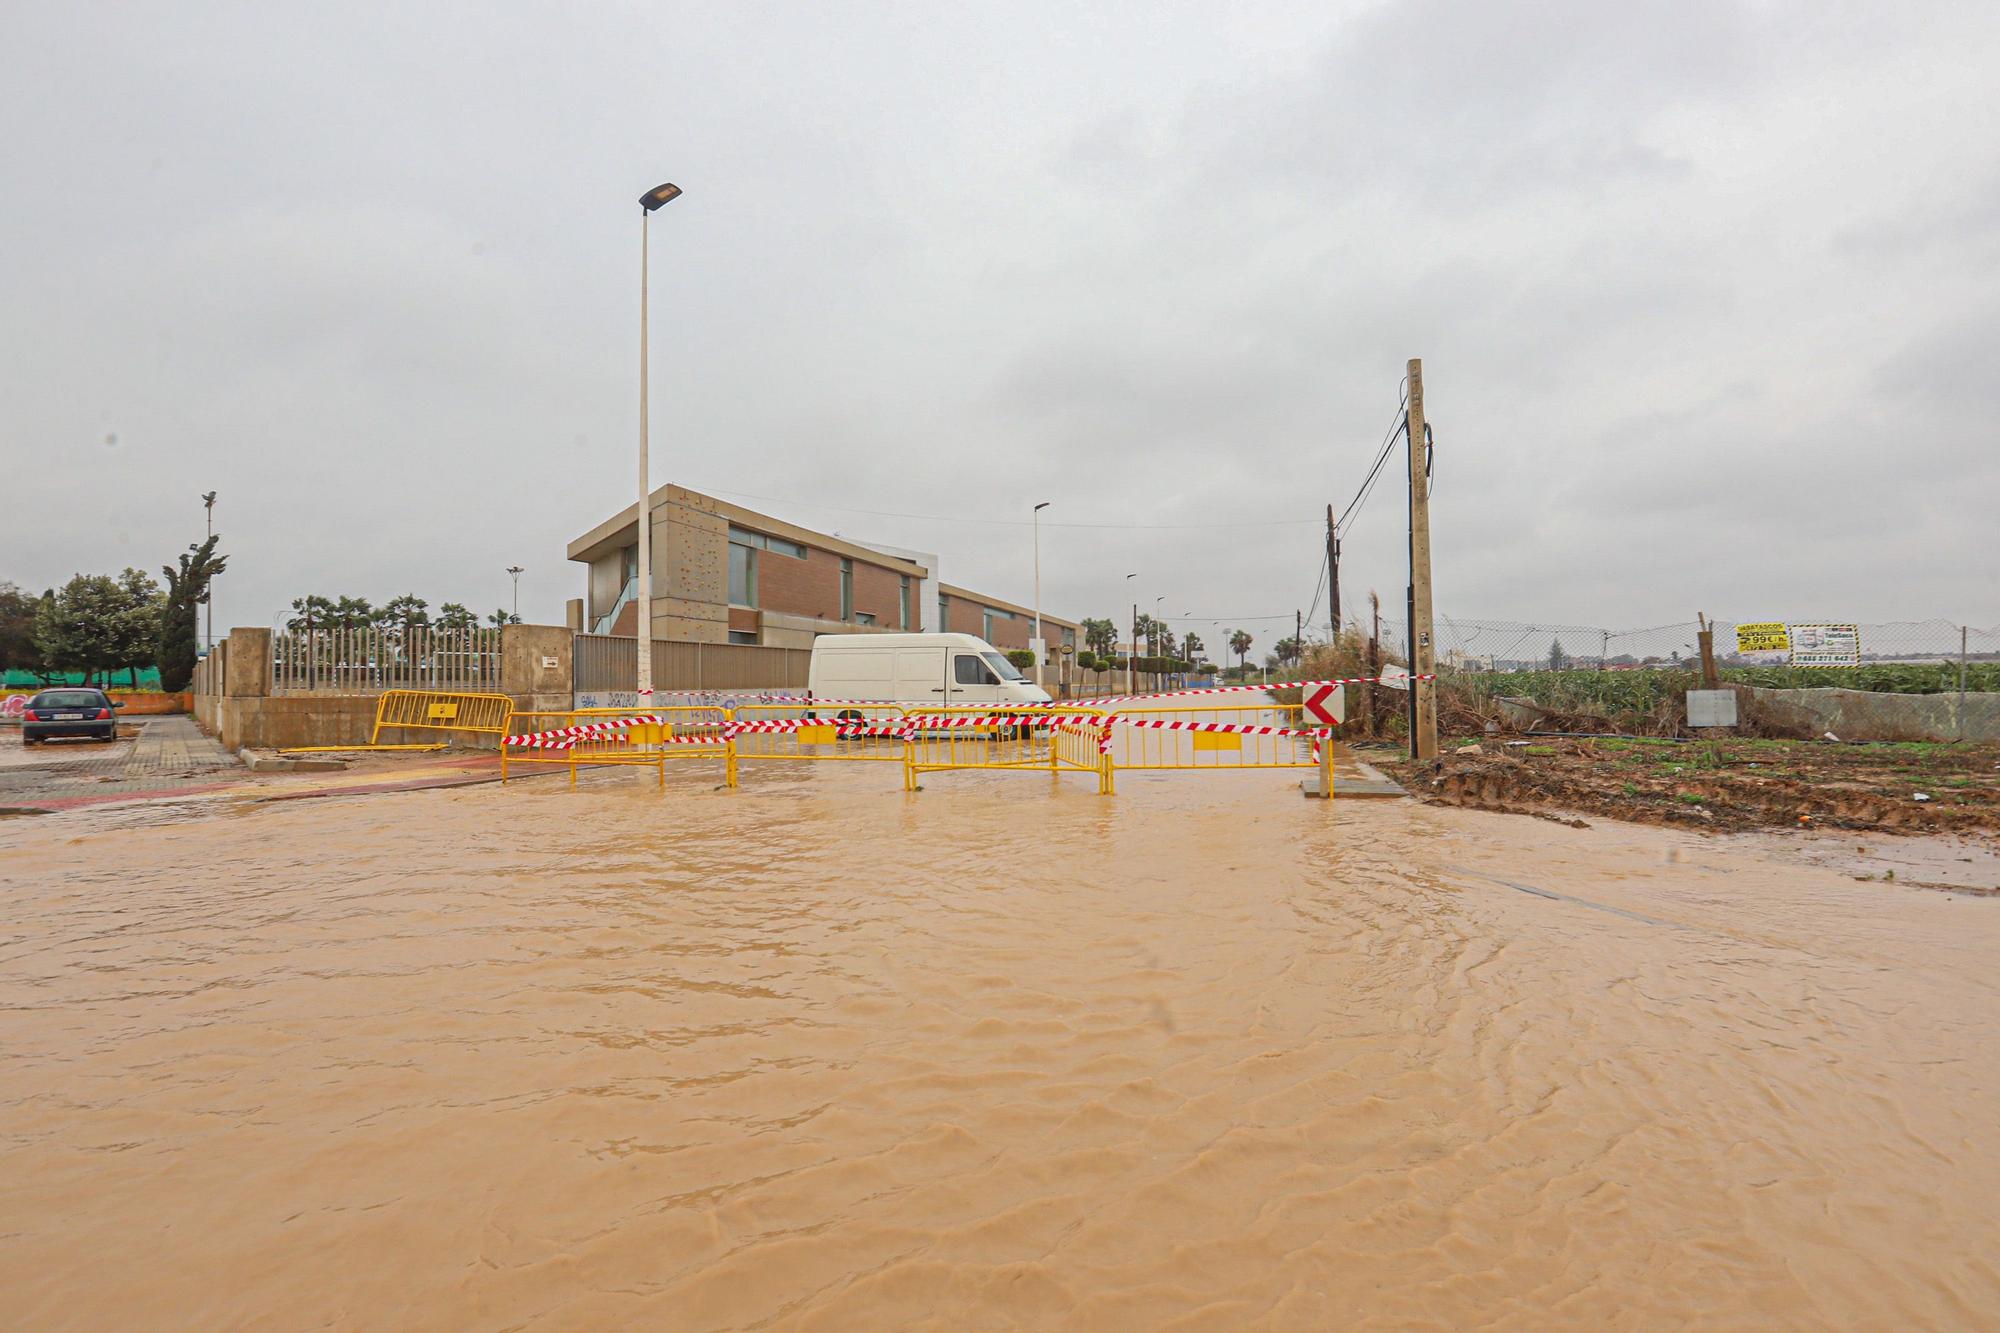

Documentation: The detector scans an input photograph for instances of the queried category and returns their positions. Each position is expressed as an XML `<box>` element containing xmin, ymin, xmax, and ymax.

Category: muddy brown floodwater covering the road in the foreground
<box><xmin>0</xmin><ymin>765</ymin><xmax>2000</xmax><ymax>1329</ymax></box>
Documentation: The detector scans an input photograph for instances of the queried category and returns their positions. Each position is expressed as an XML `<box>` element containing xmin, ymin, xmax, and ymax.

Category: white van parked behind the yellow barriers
<box><xmin>808</xmin><ymin>634</ymin><xmax>1050</xmax><ymax>709</ymax></box>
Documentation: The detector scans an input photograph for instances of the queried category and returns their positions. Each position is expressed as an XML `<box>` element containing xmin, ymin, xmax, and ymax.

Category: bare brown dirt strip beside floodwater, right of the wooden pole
<box><xmin>1382</xmin><ymin>737</ymin><xmax>2000</xmax><ymax>835</ymax></box>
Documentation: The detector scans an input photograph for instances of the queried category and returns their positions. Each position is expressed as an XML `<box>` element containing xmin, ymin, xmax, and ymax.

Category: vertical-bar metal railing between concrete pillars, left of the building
<box><xmin>270</xmin><ymin>626</ymin><xmax>500</xmax><ymax>695</ymax></box>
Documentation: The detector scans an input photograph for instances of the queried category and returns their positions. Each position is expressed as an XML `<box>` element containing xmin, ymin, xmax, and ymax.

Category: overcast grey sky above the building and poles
<box><xmin>0</xmin><ymin>0</ymin><xmax>2000</xmax><ymax>646</ymax></box>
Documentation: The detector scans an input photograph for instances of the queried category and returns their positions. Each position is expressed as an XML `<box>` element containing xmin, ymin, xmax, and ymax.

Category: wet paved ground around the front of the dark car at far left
<box><xmin>0</xmin><ymin>715</ymin><xmax>248</xmax><ymax>811</ymax></box>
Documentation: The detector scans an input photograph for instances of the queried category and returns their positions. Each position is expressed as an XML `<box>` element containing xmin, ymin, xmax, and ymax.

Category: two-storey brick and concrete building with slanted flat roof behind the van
<box><xmin>568</xmin><ymin>486</ymin><xmax>1080</xmax><ymax>648</ymax></box>
